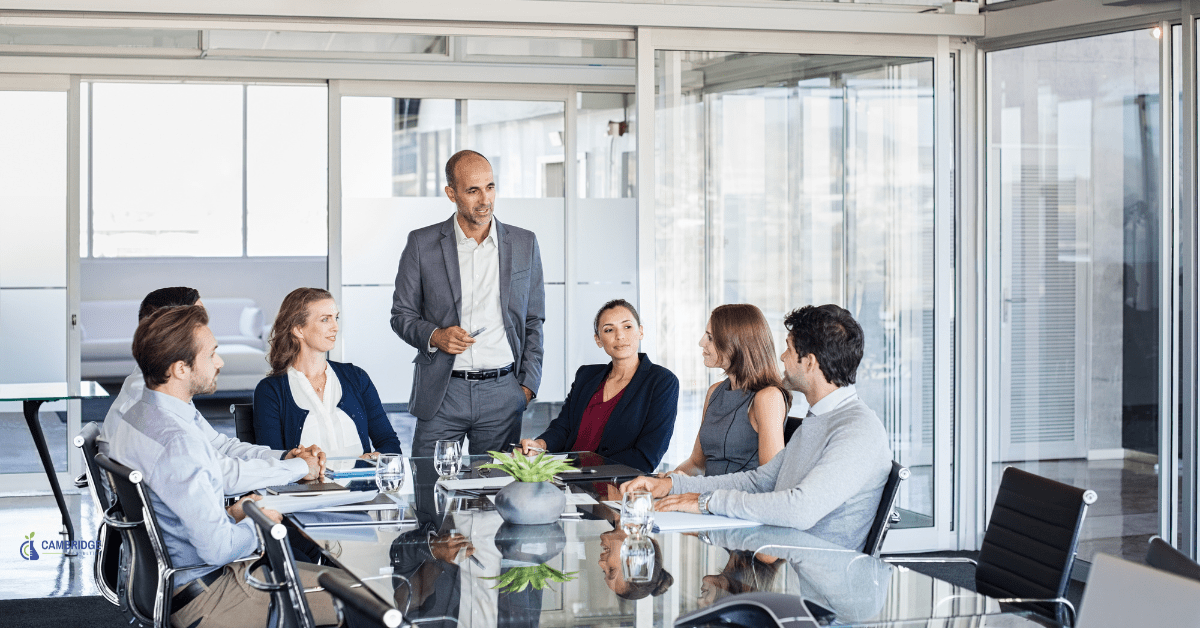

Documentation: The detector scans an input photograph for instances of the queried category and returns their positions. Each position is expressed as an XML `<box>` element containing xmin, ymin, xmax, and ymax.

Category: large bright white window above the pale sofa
<box><xmin>80</xmin><ymin>83</ymin><xmax>328</xmax><ymax>257</ymax></box>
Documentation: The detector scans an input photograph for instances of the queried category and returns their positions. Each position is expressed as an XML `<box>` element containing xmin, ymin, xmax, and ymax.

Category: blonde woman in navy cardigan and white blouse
<box><xmin>254</xmin><ymin>288</ymin><xmax>401</xmax><ymax>457</ymax></box>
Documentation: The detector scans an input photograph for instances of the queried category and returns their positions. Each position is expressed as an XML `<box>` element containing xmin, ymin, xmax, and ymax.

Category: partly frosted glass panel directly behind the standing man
<box><xmin>341</xmin><ymin>96</ymin><xmax>574</xmax><ymax>403</ymax></box>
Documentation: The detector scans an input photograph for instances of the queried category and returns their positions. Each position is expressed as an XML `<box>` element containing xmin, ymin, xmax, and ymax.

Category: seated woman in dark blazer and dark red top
<box><xmin>521</xmin><ymin>299</ymin><xmax>679</xmax><ymax>473</ymax></box>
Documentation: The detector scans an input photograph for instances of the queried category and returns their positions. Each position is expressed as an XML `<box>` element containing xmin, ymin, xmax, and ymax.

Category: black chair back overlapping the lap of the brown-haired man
<box><xmin>242</xmin><ymin>501</ymin><xmax>316</xmax><ymax>628</ymax></box>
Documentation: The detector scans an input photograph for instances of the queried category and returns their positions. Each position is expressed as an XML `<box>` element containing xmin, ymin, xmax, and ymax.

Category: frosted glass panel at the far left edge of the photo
<box><xmin>0</xmin><ymin>91</ymin><xmax>74</xmax><ymax>473</ymax></box>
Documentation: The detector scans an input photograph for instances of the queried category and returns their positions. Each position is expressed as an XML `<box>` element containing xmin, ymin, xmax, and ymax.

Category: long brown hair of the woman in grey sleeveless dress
<box><xmin>708</xmin><ymin>303</ymin><xmax>792</xmax><ymax>408</ymax></box>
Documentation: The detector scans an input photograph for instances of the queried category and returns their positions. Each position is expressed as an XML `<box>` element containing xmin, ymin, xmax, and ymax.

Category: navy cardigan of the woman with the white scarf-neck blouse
<box><xmin>254</xmin><ymin>360</ymin><xmax>402</xmax><ymax>454</ymax></box>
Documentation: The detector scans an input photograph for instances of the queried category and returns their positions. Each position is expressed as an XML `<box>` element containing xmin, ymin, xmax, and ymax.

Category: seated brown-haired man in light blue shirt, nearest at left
<box><xmin>100</xmin><ymin>305</ymin><xmax>337</xmax><ymax>628</ymax></box>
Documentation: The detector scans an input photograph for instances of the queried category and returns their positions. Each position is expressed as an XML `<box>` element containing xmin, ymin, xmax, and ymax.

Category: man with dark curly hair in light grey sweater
<box><xmin>620</xmin><ymin>305</ymin><xmax>892</xmax><ymax>550</ymax></box>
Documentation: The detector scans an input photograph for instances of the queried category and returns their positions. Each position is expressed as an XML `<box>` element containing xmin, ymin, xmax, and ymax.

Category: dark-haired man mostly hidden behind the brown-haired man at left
<box><xmin>100</xmin><ymin>287</ymin><xmax>324</xmax><ymax>496</ymax></box>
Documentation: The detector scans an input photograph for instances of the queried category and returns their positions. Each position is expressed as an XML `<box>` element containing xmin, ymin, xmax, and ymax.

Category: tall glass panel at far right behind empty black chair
<box><xmin>988</xmin><ymin>29</ymin><xmax>1169</xmax><ymax>560</ymax></box>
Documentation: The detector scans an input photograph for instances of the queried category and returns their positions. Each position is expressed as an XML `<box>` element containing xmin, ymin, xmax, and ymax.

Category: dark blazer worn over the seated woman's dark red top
<box><xmin>538</xmin><ymin>353</ymin><xmax>679</xmax><ymax>473</ymax></box>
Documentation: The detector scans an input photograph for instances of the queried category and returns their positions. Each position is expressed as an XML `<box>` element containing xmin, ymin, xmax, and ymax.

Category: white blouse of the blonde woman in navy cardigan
<box><xmin>288</xmin><ymin>363</ymin><xmax>362</xmax><ymax>457</ymax></box>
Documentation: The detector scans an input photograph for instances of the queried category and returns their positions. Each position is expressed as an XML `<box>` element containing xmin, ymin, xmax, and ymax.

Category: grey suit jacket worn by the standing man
<box><xmin>391</xmin><ymin>216</ymin><xmax>546</xmax><ymax>419</ymax></box>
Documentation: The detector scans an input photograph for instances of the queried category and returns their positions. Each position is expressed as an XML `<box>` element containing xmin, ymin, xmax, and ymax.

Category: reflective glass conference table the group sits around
<box><xmin>289</xmin><ymin>454</ymin><xmax>1058</xmax><ymax>628</ymax></box>
